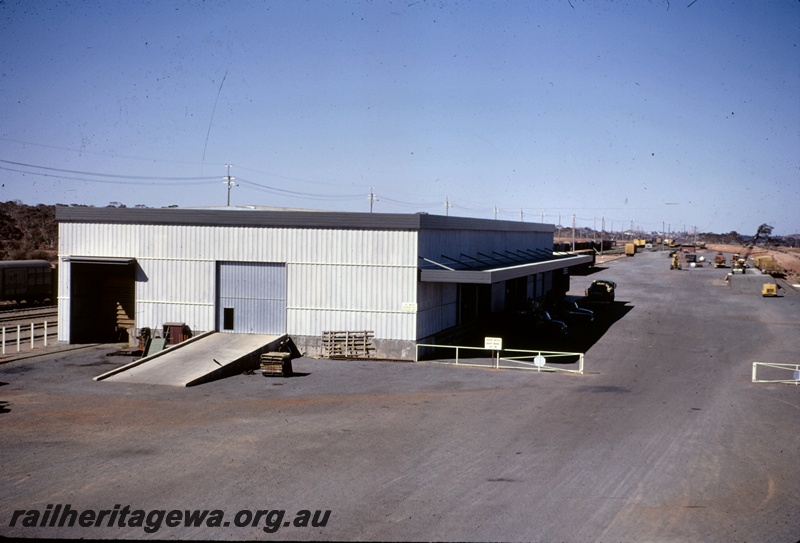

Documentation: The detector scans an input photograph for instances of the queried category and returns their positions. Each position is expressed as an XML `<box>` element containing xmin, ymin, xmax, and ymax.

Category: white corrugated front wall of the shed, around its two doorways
<box><xmin>59</xmin><ymin>223</ymin><xmax>417</xmax><ymax>341</ymax></box>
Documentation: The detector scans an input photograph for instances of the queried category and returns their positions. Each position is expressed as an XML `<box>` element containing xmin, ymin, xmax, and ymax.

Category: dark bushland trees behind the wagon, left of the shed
<box><xmin>0</xmin><ymin>201</ymin><xmax>58</xmax><ymax>262</ymax></box>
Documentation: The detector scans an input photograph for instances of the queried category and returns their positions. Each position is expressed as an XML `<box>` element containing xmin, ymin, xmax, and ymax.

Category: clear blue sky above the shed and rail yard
<box><xmin>0</xmin><ymin>0</ymin><xmax>800</xmax><ymax>234</ymax></box>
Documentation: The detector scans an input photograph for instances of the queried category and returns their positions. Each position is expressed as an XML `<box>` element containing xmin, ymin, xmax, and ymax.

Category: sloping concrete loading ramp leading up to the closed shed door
<box><xmin>94</xmin><ymin>332</ymin><xmax>294</xmax><ymax>387</ymax></box>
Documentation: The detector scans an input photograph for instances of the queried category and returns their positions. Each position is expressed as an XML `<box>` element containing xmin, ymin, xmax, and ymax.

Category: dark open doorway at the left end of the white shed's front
<box><xmin>69</xmin><ymin>259</ymin><xmax>136</xmax><ymax>343</ymax></box>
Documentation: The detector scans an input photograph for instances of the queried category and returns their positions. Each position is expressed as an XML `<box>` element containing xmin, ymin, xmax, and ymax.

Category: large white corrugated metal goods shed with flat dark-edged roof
<box><xmin>56</xmin><ymin>207</ymin><xmax>588</xmax><ymax>359</ymax></box>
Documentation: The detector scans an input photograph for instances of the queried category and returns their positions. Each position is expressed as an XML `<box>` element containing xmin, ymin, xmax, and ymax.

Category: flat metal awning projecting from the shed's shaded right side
<box><xmin>420</xmin><ymin>249</ymin><xmax>593</xmax><ymax>285</ymax></box>
